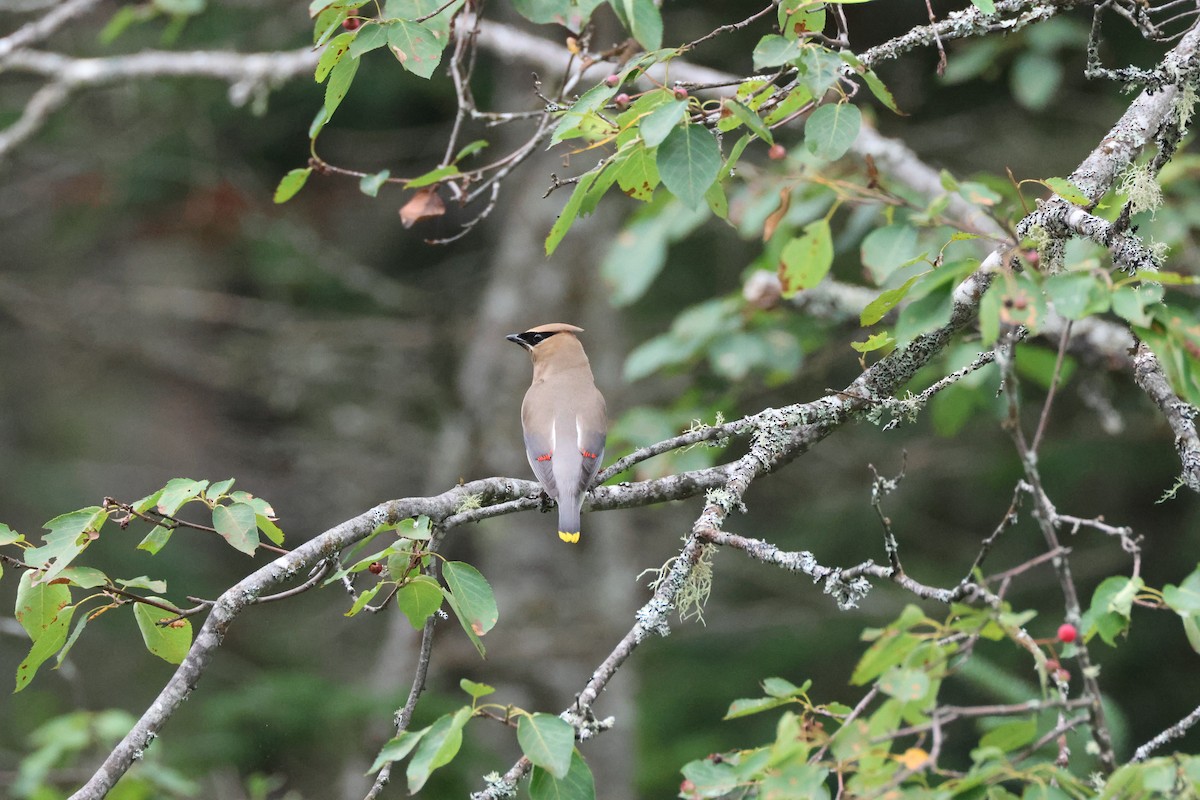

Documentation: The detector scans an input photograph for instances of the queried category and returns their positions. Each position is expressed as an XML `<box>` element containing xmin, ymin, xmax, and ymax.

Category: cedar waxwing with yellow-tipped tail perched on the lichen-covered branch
<box><xmin>506</xmin><ymin>323</ymin><xmax>608</xmax><ymax>542</ymax></box>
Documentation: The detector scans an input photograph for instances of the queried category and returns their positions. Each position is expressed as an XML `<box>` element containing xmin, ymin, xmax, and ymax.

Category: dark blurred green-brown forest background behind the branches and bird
<box><xmin>0</xmin><ymin>0</ymin><xmax>1200</xmax><ymax>798</ymax></box>
